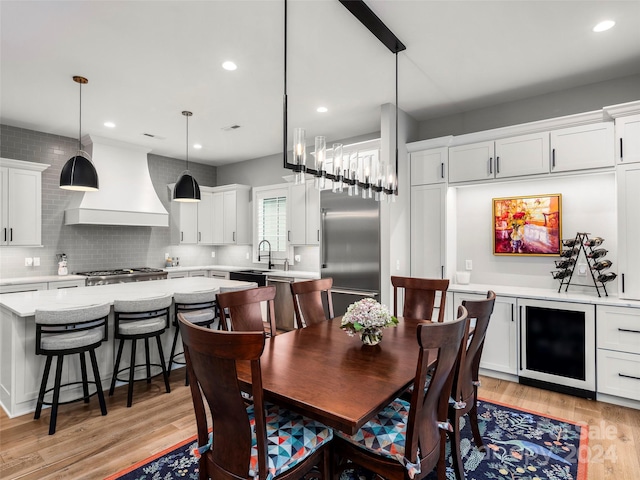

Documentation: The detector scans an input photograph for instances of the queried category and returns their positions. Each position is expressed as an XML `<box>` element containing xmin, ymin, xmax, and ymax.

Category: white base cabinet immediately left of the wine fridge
<box><xmin>451</xmin><ymin>292</ymin><xmax>518</xmax><ymax>375</ymax></box>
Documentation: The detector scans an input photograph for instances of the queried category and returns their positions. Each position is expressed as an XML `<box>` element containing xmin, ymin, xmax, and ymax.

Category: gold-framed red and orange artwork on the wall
<box><xmin>493</xmin><ymin>193</ymin><xmax>562</xmax><ymax>255</ymax></box>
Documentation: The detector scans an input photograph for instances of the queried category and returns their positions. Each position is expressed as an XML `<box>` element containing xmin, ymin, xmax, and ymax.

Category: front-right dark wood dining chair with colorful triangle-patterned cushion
<box><xmin>332</xmin><ymin>306</ymin><xmax>469</xmax><ymax>480</ymax></box>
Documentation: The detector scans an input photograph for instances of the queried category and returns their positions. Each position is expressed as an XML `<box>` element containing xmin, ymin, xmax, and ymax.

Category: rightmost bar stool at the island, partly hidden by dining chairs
<box><xmin>169</xmin><ymin>289</ymin><xmax>218</xmax><ymax>385</ymax></box>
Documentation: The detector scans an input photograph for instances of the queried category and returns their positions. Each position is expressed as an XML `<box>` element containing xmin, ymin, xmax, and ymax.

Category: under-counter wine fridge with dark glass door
<box><xmin>518</xmin><ymin>299</ymin><xmax>596</xmax><ymax>398</ymax></box>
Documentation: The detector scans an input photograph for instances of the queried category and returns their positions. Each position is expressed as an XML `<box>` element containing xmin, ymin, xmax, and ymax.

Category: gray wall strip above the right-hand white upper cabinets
<box><xmin>419</xmin><ymin>75</ymin><xmax>640</xmax><ymax>140</ymax></box>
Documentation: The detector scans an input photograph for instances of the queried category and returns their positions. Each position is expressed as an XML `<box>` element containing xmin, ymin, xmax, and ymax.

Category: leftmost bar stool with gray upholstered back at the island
<box><xmin>33</xmin><ymin>303</ymin><xmax>111</xmax><ymax>435</ymax></box>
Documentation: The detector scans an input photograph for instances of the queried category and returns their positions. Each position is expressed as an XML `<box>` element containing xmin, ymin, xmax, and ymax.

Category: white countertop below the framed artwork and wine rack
<box><xmin>448</xmin><ymin>283</ymin><xmax>640</xmax><ymax>308</ymax></box>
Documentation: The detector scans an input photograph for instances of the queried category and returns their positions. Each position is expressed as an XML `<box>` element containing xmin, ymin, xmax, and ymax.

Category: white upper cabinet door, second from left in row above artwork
<box><xmin>449</xmin><ymin>141</ymin><xmax>495</xmax><ymax>183</ymax></box>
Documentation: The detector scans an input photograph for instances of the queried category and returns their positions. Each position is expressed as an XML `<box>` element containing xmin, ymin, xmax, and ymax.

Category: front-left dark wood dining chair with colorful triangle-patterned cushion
<box><xmin>179</xmin><ymin>316</ymin><xmax>333</xmax><ymax>480</ymax></box>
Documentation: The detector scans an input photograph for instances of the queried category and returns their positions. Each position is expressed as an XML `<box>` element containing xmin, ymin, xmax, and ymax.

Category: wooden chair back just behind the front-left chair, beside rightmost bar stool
<box><xmin>218</xmin><ymin>286</ymin><xmax>276</xmax><ymax>335</ymax></box>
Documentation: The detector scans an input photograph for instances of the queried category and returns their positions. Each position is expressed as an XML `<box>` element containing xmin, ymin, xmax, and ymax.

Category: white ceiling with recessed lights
<box><xmin>0</xmin><ymin>0</ymin><xmax>640</xmax><ymax>165</ymax></box>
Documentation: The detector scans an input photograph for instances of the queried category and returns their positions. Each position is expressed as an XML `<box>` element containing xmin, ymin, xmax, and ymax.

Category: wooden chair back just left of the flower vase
<box><xmin>291</xmin><ymin>278</ymin><xmax>334</xmax><ymax>328</ymax></box>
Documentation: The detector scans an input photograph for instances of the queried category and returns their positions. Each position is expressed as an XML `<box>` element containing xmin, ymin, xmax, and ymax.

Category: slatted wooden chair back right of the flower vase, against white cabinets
<box><xmin>391</xmin><ymin>277</ymin><xmax>449</xmax><ymax>322</ymax></box>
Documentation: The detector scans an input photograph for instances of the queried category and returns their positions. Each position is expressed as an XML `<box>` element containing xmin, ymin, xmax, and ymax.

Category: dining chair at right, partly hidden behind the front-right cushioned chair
<box><xmin>448</xmin><ymin>290</ymin><xmax>496</xmax><ymax>480</ymax></box>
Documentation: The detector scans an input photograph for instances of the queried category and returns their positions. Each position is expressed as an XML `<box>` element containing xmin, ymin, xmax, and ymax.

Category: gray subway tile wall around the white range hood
<box><xmin>0</xmin><ymin>125</ymin><xmax>216</xmax><ymax>278</ymax></box>
